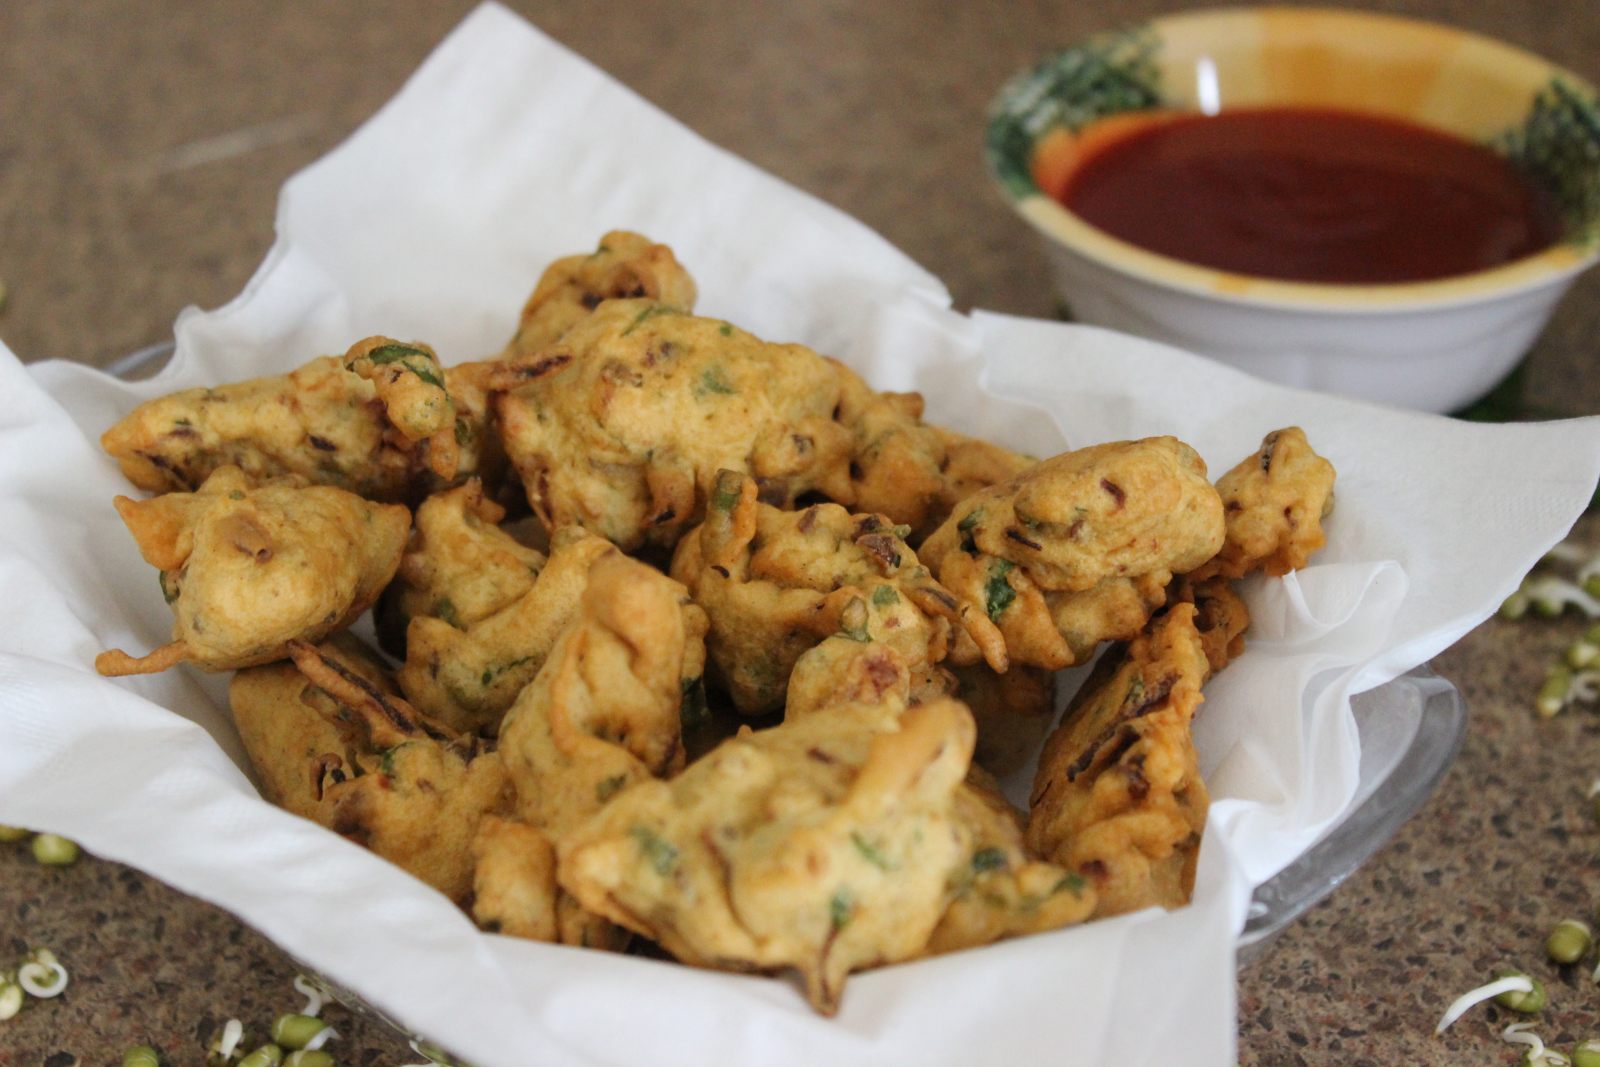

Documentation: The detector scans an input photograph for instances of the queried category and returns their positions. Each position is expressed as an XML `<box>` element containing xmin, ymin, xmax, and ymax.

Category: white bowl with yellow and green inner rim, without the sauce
<box><xmin>986</xmin><ymin>8</ymin><xmax>1600</xmax><ymax>411</ymax></box>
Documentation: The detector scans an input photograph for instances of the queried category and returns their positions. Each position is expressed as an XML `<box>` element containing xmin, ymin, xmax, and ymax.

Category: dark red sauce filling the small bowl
<box><xmin>1061</xmin><ymin>107</ymin><xmax>1562</xmax><ymax>285</ymax></box>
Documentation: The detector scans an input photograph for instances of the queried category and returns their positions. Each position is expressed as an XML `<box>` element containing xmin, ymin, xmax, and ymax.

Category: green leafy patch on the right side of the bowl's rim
<box><xmin>1491</xmin><ymin>78</ymin><xmax>1600</xmax><ymax>245</ymax></box>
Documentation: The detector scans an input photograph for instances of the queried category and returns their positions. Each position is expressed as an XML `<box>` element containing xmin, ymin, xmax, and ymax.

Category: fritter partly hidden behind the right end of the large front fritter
<box><xmin>926</xmin><ymin>776</ymin><xmax>1098</xmax><ymax>955</ymax></box>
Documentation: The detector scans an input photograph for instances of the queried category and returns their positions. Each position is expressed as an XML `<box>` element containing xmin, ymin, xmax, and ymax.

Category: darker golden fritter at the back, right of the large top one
<box><xmin>830</xmin><ymin>367</ymin><xmax>1032</xmax><ymax>542</ymax></box>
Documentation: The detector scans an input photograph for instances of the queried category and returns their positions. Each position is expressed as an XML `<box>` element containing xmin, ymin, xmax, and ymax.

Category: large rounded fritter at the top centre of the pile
<box><xmin>494</xmin><ymin>301</ymin><xmax>851</xmax><ymax>552</ymax></box>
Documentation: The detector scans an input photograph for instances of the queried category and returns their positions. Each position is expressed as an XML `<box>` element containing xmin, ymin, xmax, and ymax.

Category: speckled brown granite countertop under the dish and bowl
<box><xmin>0</xmin><ymin>0</ymin><xmax>1600</xmax><ymax>1067</ymax></box>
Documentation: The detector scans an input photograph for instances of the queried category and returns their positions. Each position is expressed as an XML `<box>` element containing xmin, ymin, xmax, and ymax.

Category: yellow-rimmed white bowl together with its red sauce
<box><xmin>986</xmin><ymin>8</ymin><xmax>1600</xmax><ymax>411</ymax></box>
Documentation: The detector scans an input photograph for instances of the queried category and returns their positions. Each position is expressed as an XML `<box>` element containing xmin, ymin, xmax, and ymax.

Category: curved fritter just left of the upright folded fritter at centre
<box><xmin>398</xmin><ymin>521</ymin><xmax>616</xmax><ymax>733</ymax></box>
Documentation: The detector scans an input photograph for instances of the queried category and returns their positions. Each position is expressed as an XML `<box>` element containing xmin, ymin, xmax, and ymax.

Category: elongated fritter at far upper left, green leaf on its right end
<box><xmin>101</xmin><ymin>338</ymin><xmax>486</xmax><ymax>501</ymax></box>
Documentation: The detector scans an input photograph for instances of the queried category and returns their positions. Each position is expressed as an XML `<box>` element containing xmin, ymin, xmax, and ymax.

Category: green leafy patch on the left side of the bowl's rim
<box><xmin>984</xmin><ymin>26</ymin><xmax>1162</xmax><ymax>197</ymax></box>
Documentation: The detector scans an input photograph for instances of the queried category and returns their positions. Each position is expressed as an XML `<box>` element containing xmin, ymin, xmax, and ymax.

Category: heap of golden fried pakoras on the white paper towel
<box><xmin>96</xmin><ymin>232</ymin><xmax>1334</xmax><ymax>1013</ymax></box>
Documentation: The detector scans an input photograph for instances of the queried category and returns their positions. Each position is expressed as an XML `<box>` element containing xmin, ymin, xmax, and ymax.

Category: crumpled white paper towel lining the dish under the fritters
<box><xmin>0</xmin><ymin>5</ymin><xmax>1600</xmax><ymax>1067</ymax></box>
